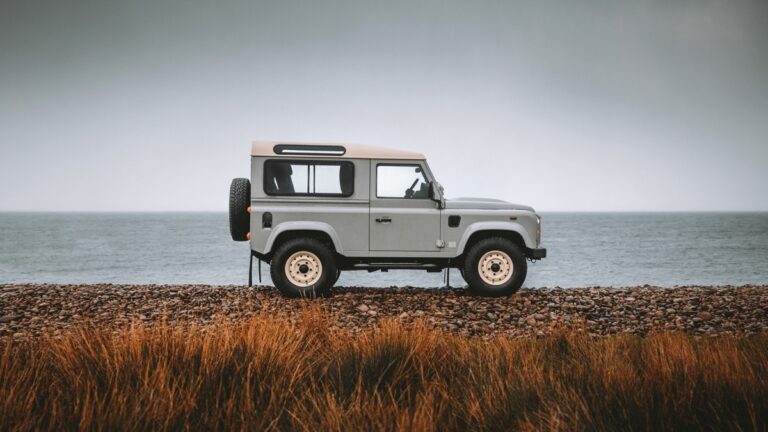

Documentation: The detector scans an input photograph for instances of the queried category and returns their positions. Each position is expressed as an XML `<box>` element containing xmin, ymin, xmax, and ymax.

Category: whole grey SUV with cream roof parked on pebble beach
<box><xmin>229</xmin><ymin>142</ymin><xmax>546</xmax><ymax>297</ymax></box>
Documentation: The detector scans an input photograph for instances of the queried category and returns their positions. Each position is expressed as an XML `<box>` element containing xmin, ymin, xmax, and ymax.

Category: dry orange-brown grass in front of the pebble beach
<box><xmin>0</xmin><ymin>311</ymin><xmax>768</xmax><ymax>431</ymax></box>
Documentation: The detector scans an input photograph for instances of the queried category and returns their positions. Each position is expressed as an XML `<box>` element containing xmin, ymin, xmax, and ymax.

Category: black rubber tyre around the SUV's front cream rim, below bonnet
<box><xmin>463</xmin><ymin>237</ymin><xmax>528</xmax><ymax>297</ymax></box>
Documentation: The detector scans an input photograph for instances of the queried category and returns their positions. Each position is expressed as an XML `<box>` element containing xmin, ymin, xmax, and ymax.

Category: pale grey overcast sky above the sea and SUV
<box><xmin>0</xmin><ymin>0</ymin><xmax>768</xmax><ymax>211</ymax></box>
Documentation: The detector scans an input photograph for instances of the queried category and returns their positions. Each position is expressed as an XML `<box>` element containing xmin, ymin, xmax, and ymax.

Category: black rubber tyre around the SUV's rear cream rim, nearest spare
<box><xmin>270</xmin><ymin>238</ymin><xmax>339</xmax><ymax>298</ymax></box>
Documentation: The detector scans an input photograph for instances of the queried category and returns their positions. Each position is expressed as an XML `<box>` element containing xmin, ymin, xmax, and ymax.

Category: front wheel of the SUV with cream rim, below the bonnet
<box><xmin>463</xmin><ymin>237</ymin><xmax>528</xmax><ymax>297</ymax></box>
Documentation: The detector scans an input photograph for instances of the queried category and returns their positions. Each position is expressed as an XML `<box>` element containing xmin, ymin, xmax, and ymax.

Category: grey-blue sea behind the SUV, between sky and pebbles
<box><xmin>0</xmin><ymin>213</ymin><xmax>768</xmax><ymax>288</ymax></box>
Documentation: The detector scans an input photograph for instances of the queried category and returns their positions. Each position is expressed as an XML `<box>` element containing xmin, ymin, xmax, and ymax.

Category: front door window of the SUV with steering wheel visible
<box><xmin>376</xmin><ymin>164</ymin><xmax>429</xmax><ymax>198</ymax></box>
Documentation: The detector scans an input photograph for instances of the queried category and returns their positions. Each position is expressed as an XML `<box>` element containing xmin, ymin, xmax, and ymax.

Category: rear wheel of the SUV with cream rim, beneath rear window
<box><xmin>270</xmin><ymin>238</ymin><xmax>338</xmax><ymax>298</ymax></box>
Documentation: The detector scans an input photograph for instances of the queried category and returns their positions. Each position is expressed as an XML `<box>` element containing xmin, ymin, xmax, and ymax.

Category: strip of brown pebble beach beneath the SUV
<box><xmin>0</xmin><ymin>284</ymin><xmax>768</xmax><ymax>338</ymax></box>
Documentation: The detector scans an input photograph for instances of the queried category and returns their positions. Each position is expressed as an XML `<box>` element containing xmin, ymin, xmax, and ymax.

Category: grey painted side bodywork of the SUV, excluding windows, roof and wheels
<box><xmin>250</xmin><ymin>156</ymin><xmax>539</xmax><ymax>258</ymax></box>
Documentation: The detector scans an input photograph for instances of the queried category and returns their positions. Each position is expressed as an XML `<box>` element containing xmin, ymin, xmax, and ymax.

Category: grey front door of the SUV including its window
<box><xmin>370</xmin><ymin>161</ymin><xmax>440</xmax><ymax>251</ymax></box>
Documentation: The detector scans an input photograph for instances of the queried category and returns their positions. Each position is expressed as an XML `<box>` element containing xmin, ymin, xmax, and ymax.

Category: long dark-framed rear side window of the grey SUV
<box><xmin>264</xmin><ymin>159</ymin><xmax>355</xmax><ymax>197</ymax></box>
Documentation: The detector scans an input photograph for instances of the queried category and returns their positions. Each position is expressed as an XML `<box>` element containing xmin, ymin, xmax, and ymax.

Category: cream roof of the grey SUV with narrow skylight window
<box><xmin>251</xmin><ymin>141</ymin><xmax>426</xmax><ymax>159</ymax></box>
